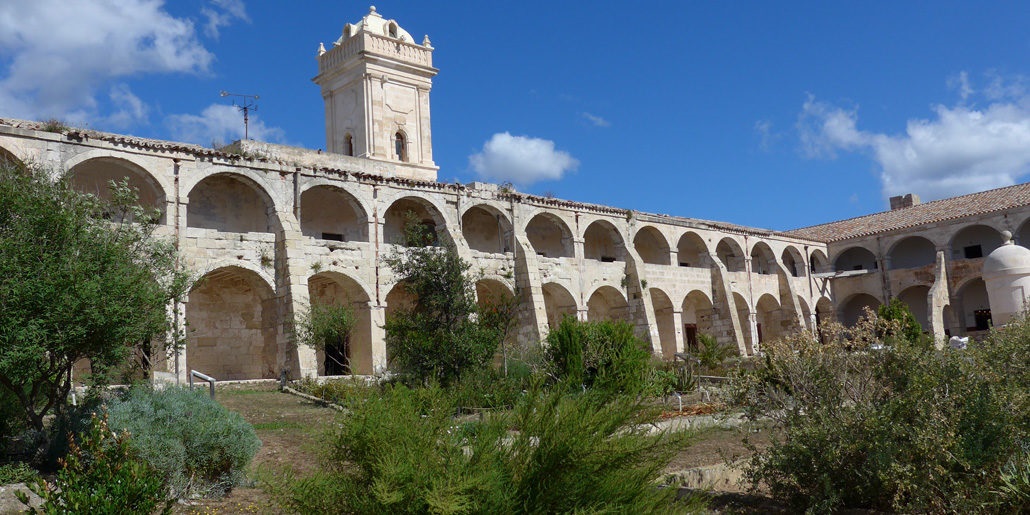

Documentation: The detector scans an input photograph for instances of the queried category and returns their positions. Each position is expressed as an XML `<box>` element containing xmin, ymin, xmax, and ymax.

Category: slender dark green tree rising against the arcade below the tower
<box><xmin>384</xmin><ymin>213</ymin><xmax>510</xmax><ymax>385</ymax></box>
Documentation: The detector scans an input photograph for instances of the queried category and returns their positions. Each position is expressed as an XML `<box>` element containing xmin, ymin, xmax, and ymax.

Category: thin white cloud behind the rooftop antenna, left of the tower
<box><xmin>166</xmin><ymin>104</ymin><xmax>285</xmax><ymax>145</ymax></box>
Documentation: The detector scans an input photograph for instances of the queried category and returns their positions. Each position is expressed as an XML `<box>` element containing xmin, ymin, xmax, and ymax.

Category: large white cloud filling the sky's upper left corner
<box><xmin>0</xmin><ymin>0</ymin><xmax>213</xmax><ymax>122</ymax></box>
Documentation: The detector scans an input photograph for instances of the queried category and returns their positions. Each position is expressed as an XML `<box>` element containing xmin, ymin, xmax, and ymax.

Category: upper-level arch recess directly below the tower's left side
<box><xmin>301</xmin><ymin>185</ymin><xmax>369</xmax><ymax>241</ymax></box>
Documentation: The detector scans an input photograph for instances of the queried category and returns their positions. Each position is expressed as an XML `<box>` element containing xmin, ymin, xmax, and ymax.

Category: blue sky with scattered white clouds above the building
<box><xmin>0</xmin><ymin>0</ymin><xmax>1030</xmax><ymax>230</ymax></box>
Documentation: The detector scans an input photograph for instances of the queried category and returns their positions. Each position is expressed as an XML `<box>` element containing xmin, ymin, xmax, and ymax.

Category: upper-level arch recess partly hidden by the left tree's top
<box><xmin>68</xmin><ymin>157</ymin><xmax>167</xmax><ymax>224</ymax></box>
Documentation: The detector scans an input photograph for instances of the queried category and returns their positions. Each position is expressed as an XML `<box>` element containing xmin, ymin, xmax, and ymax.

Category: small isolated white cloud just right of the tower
<box><xmin>469</xmin><ymin>132</ymin><xmax>579</xmax><ymax>185</ymax></box>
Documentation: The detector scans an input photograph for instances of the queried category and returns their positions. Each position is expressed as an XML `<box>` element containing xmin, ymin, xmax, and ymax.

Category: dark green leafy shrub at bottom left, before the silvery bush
<box><xmin>15</xmin><ymin>415</ymin><xmax>175</xmax><ymax>515</ymax></box>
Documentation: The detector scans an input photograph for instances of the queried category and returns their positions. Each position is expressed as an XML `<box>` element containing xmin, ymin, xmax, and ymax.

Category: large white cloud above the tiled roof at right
<box><xmin>797</xmin><ymin>82</ymin><xmax>1030</xmax><ymax>200</ymax></box>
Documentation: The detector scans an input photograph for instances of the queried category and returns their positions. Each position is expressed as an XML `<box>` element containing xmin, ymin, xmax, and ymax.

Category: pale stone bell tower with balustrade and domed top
<box><xmin>313</xmin><ymin>6</ymin><xmax>439</xmax><ymax>180</ymax></box>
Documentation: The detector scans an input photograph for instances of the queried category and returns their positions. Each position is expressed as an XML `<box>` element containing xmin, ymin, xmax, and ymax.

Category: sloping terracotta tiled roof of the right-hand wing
<box><xmin>787</xmin><ymin>182</ymin><xmax>1030</xmax><ymax>243</ymax></box>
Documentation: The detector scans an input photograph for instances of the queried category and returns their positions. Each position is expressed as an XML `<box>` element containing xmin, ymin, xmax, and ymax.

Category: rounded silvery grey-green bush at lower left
<box><xmin>109</xmin><ymin>386</ymin><xmax>261</xmax><ymax>497</ymax></box>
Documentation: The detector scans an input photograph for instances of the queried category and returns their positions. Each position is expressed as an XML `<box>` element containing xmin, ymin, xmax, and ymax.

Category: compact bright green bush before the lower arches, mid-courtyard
<box><xmin>546</xmin><ymin>316</ymin><xmax>651</xmax><ymax>394</ymax></box>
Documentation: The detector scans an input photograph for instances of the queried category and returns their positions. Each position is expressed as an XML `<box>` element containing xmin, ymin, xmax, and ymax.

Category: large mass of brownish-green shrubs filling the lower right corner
<box><xmin>734</xmin><ymin>307</ymin><xmax>1030</xmax><ymax>512</ymax></box>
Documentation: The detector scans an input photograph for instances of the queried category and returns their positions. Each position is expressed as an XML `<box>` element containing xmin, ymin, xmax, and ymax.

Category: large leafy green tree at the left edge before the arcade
<box><xmin>0</xmin><ymin>163</ymin><xmax>188</xmax><ymax>440</ymax></box>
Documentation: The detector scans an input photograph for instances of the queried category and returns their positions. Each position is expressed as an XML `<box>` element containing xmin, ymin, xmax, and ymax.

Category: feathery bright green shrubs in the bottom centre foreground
<box><xmin>278</xmin><ymin>386</ymin><xmax>698</xmax><ymax>514</ymax></box>
